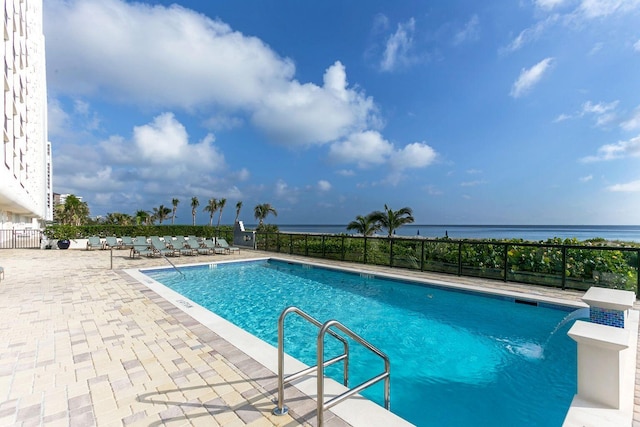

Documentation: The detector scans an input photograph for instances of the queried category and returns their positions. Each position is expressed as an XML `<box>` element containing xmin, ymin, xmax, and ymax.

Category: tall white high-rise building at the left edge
<box><xmin>0</xmin><ymin>0</ymin><xmax>53</xmax><ymax>230</ymax></box>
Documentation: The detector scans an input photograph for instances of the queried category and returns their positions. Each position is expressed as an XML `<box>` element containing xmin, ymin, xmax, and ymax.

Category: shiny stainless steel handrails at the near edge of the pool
<box><xmin>271</xmin><ymin>307</ymin><xmax>391</xmax><ymax>427</ymax></box>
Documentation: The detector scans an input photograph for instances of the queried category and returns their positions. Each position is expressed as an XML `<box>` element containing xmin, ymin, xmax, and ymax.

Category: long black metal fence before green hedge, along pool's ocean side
<box><xmin>256</xmin><ymin>233</ymin><xmax>640</xmax><ymax>298</ymax></box>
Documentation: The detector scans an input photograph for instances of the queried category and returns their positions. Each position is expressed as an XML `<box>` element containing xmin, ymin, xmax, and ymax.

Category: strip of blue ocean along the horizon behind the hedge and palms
<box><xmin>247</xmin><ymin>224</ymin><xmax>640</xmax><ymax>242</ymax></box>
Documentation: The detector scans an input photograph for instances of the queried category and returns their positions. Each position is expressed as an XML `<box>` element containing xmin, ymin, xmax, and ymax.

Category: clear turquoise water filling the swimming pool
<box><xmin>145</xmin><ymin>260</ymin><xmax>576</xmax><ymax>426</ymax></box>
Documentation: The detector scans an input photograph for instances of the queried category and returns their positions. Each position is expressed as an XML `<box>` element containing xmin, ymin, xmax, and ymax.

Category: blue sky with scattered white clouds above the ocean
<box><xmin>44</xmin><ymin>0</ymin><xmax>640</xmax><ymax>225</ymax></box>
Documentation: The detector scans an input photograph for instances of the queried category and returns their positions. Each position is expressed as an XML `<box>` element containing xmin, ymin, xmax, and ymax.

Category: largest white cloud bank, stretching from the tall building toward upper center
<box><xmin>45</xmin><ymin>0</ymin><xmax>380</xmax><ymax>149</ymax></box>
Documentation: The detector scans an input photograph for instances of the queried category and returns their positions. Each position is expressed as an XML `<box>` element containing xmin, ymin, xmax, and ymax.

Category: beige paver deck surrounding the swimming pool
<box><xmin>0</xmin><ymin>249</ymin><xmax>640</xmax><ymax>427</ymax></box>
